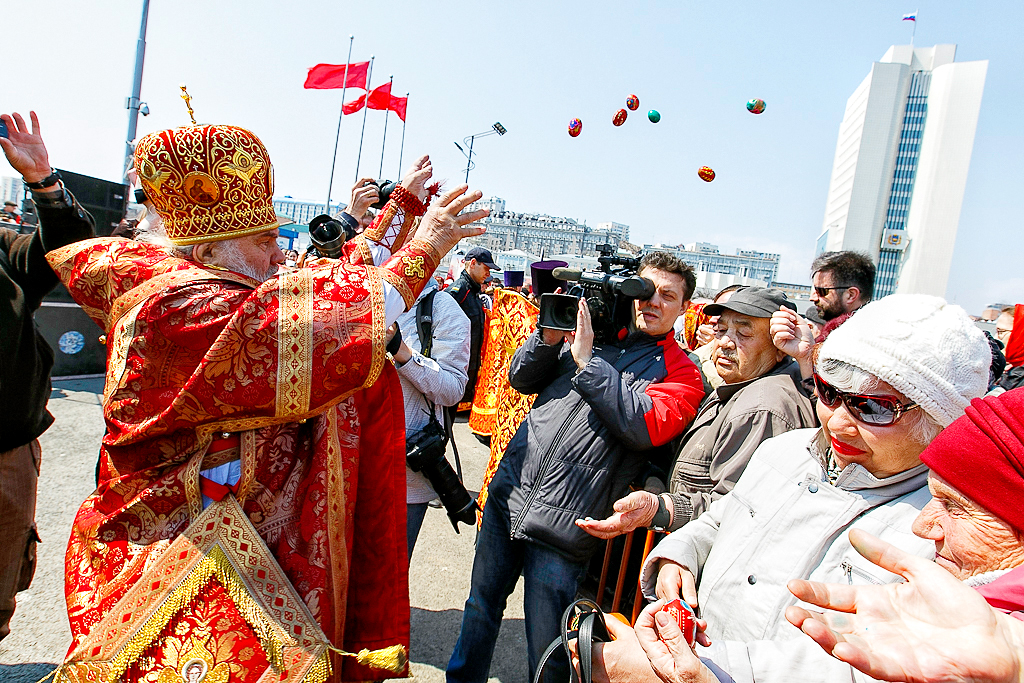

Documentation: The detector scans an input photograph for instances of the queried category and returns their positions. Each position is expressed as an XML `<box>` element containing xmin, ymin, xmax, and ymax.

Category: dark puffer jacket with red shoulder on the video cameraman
<box><xmin>496</xmin><ymin>332</ymin><xmax>703</xmax><ymax>562</ymax></box>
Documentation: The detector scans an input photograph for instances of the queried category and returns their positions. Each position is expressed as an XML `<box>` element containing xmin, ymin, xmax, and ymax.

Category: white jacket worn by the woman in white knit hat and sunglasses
<box><xmin>641</xmin><ymin>429</ymin><xmax>935</xmax><ymax>683</ymax></box>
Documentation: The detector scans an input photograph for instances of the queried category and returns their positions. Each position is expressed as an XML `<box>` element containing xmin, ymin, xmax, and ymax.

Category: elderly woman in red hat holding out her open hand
<box><xmin>786</xmin><ymin>388</ymin><xmax>1024</xmax><ymax>680</ymax></box>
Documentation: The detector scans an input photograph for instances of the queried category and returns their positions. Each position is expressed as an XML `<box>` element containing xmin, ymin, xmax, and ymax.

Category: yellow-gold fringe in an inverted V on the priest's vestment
<box><xmin>108</xmin><ymin>546</ymin><xmax>288</xmax><ymax>683</ymax></box>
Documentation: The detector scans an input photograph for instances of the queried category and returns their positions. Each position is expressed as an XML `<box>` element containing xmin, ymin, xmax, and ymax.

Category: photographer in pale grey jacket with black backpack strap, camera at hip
<box><xmin>392</xmin><ymin>279</ymin><xmax>470</xmax><ymax>561</ymax></box>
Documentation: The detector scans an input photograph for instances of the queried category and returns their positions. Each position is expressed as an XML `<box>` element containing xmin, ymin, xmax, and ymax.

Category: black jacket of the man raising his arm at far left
<box><xmin>0</xmin><ymin>188</ymin><xmax>93</xmax><ymax>453</ymax></box>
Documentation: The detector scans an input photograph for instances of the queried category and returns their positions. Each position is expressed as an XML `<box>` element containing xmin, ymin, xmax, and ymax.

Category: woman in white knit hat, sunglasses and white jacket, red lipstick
<box><xmin>595</xmin><ymin>295</ymin><xmax>990</xmax><ymax>681</ymax></box>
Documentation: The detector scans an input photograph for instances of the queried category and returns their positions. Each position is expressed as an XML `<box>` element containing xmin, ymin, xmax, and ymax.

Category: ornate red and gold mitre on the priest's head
<box><xmin>135</xmin><ymin>125</ymin><xmax>278</xmax><ymax>246</ymax></box>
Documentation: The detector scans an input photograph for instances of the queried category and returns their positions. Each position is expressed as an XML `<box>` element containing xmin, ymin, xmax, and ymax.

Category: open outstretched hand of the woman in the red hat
<box><xmin>785</xmin><ymin>529</ymin><xmax>1022</xmax><ymax>683</ymax></box>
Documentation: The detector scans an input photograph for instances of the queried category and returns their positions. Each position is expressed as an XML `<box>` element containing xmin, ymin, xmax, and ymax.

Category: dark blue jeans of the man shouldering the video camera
<box><xmin>446</xmin><ymin>469</ymin><xmax>587</xmax><ymax>683</ymax></box>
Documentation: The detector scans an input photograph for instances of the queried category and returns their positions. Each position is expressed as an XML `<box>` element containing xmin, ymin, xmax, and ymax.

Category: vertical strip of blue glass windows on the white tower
<box><xmin>874</xmin><ymin>72</ymin><xmax>932</xmax><ymax>298</ymax></box>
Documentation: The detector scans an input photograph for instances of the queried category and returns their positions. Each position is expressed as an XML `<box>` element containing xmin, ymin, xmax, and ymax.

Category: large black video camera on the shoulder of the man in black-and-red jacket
<box><xmin>537</xmin><ymin>245</ymin><xmax>654</xmax><ymax>344</ymax></box>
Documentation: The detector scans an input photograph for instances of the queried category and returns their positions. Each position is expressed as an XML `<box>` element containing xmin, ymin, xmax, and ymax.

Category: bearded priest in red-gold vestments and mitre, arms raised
<box><xmin>48</xmin><ymin>125</ymin><xmax>486</xmax><ymax>683</ymax></box>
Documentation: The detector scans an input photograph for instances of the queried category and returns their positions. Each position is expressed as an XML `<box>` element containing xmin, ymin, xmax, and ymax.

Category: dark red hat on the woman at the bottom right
<box><xmin>921</xmin><ymin>387</ymin><xmax>1024</xmax><ymax>532</ymax></box>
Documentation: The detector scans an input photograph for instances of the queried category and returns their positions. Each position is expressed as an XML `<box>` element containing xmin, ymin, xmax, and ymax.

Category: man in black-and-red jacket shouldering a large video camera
<box><xmin>447</xmin><ymin>252</ymin><xmax>703</xmax><ymax>682</ymax></box>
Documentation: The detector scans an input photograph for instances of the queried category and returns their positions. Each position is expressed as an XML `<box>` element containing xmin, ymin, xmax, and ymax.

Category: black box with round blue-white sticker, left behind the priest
<box><xmin>35</xmin><ymin>301</ymin><xmax>106</xmax><ymax>377</ymax></box>
